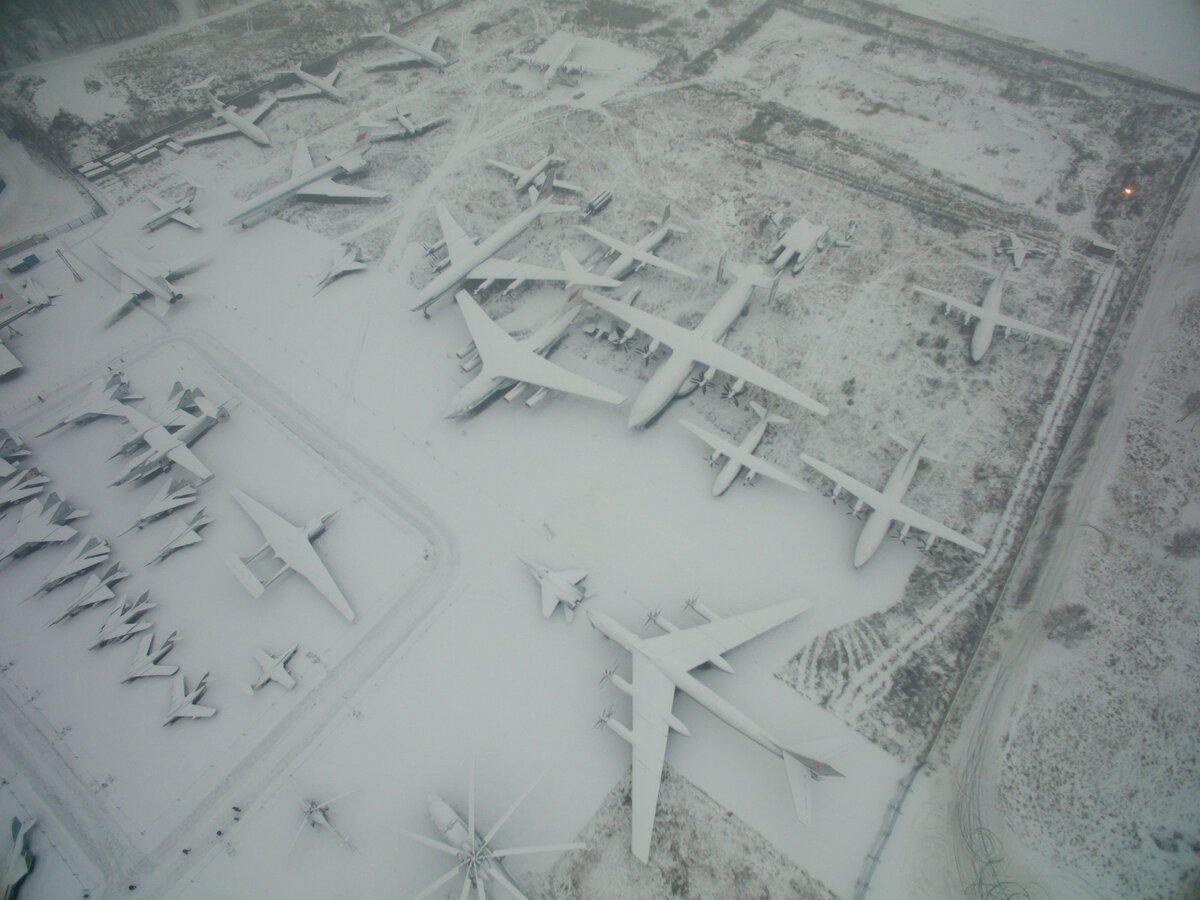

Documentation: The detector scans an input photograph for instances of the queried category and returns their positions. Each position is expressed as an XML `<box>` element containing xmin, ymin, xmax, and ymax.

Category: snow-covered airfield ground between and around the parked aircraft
<box><xmin>0</xmin><ymin>2</ymin><xmax>1200</xmax><ymax>898</ymax></box>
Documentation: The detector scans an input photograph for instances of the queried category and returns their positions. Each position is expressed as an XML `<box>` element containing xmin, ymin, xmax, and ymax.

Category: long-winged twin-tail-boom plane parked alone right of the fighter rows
<box><xmin>228</xmin><ymin>488</ymin><xmax>354</xmax><ymax>622</ymax></box>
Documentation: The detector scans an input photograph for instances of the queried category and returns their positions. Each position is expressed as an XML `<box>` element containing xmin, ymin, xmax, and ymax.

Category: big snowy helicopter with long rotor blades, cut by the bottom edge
<box><xmin>396</xmin><ymin>772</ymin><xmax>587</xmax><ymax>900</ymax></box>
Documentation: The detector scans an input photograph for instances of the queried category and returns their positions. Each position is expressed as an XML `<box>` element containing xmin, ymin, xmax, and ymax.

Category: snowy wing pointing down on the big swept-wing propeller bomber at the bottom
<box><xmin>631</xmin><ymin>653</ymin><xmax>676</xmax><ymax>862</ymax></box>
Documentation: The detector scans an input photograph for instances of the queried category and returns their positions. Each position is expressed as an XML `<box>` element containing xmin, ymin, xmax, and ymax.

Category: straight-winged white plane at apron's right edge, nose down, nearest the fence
<box><xmin>800</xmin><ymin>434</ymin><xmax>986</xmax><ymax>569</ymax></box>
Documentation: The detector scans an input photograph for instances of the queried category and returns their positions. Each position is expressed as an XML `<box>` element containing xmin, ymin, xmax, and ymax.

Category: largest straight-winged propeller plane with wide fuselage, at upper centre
<box><xmin>583</xmin><ymin>266</ymin><xmax>829</xmax><ymax>428</ymax></box>
